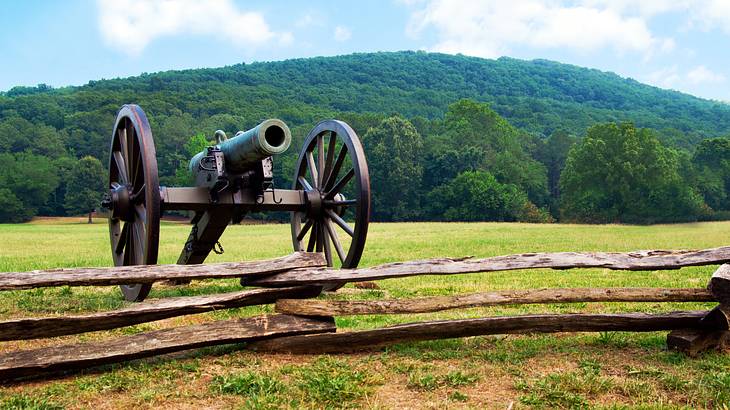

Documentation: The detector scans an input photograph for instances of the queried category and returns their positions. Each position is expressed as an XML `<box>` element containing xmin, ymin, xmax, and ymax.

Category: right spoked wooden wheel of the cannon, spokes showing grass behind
<box><xmin>291</xmin><ymin>120</ymin><xmax>370</xmax><ymax>276</ymax></box>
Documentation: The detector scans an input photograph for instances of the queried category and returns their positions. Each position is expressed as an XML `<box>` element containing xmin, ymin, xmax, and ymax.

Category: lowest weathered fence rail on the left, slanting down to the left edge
<box><xmin>0</xmin><ymin>315</ymin><xmax>335</xmax><ymax>380</ymax></box>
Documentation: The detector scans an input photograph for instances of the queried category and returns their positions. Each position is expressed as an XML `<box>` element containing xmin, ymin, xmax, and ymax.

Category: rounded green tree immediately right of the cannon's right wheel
<box><xmin>363</xmin><ymin>117</ymin><xmax>423</xmax><ymax>221</ymax></box>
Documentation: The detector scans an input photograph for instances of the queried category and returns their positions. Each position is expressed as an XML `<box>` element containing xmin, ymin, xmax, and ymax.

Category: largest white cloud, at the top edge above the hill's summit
<box><xmin>407</xmin><ymin>0</ymin><xmax>674</xmax><ymax>57</ymax></box>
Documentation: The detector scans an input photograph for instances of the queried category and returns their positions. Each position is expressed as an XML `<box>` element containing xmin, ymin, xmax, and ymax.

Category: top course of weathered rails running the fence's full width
<box><xmin>0</xmin><ymin>247</ymin><xmax>730</xmax><ymax>290</ymax></box>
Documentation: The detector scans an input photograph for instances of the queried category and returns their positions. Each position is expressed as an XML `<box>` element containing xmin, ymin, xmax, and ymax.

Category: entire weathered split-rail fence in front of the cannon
<box><xmin>0</xmin><ymin>247</ymin><xmax>730</xmax><ymax>382</ymax></box>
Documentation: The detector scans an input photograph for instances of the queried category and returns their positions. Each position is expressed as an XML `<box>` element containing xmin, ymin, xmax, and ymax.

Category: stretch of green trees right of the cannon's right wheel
<box><xmin>364</xmin><ymin>100</ymin><xmax>730</xmax><ymax>224</ymax></box>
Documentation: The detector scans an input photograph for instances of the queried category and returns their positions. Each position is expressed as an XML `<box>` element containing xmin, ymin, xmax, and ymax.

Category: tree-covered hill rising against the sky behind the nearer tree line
<box><xmin>5</xmin><ymin>52</ymin><xmax>730</xmax><ymax>157</ymax></box>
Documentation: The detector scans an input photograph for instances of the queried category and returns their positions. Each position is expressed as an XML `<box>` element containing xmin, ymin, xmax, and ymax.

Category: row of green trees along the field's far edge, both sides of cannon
<box><xmin>0</xmin><ymin>100</ymin><xmax>730</xmax><ymax>223</ymax></box>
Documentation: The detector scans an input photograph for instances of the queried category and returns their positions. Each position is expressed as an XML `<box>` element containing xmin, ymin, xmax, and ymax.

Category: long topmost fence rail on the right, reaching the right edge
<box><xmin>242</xmin><ymin>247</ymin><xmax>730</xmax><ymax>287</ymax></box>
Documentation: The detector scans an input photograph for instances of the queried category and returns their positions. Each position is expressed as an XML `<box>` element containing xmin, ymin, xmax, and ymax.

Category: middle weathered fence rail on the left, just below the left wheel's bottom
<box><xmin>0</xmin><ymin>286</ymin><xmax>322</xmax><ymax>341</ymax></box>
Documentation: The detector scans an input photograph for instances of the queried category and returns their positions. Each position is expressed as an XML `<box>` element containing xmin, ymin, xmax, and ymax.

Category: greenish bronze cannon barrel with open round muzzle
<box><xmin>189</xmin><ymin>119</ymin><xmax>291</xmax><ymax>175</ymax></box>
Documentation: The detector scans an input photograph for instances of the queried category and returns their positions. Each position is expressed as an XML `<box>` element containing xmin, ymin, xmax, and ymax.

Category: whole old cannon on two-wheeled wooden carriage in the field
<box><xmin>102</xmin><ymin>104</ymin><xmax>370</xmax><ymax>301</ymax></box>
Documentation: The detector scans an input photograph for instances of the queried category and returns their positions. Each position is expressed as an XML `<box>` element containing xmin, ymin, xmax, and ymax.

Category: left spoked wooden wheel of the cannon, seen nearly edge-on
<box><xmin>106</xmin><ymin>104</ymin><xmax>160</xmax><ymax>301</ymax></box>
